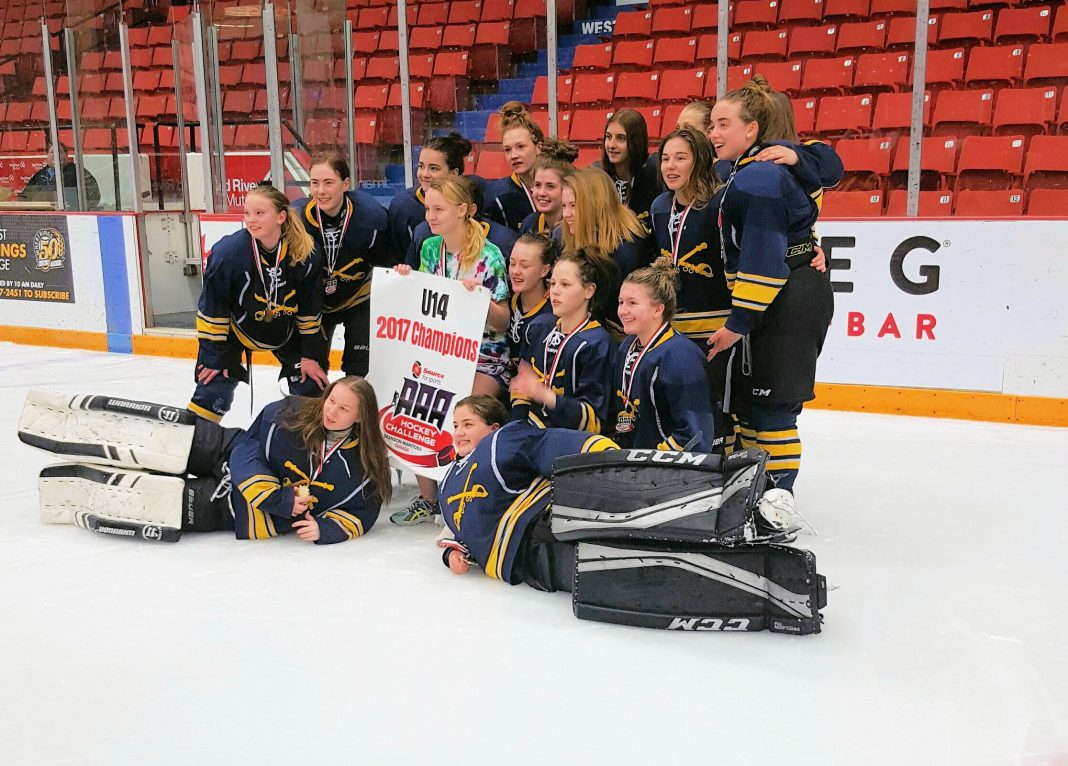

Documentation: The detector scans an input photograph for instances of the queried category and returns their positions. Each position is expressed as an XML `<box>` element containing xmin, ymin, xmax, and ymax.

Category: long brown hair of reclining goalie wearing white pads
<box><xmin>282</xmin><ymin>375</ymin><xmax>393</xmax><ymax>505</ymax></box>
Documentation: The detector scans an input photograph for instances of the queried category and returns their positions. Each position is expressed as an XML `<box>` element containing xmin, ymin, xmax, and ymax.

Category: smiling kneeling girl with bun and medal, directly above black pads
<box><xmin>608</xmin><ymin>256</ymin><xmax>714</xmax><ymax>452</ymax></box>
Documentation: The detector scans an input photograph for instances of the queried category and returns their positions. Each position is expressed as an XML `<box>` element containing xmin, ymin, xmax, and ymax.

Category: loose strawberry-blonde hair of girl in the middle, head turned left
<box><xmin>562</xmin><ymin>168</ymin><xmax>646</xmax><ymax>254</ymax></box>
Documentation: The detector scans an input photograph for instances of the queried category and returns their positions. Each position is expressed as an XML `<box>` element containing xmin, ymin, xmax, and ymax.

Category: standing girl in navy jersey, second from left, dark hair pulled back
<box><xmin>289</xmin><ymin>152</ymin><xmax>396</xmax><ymax>382</ymax></box>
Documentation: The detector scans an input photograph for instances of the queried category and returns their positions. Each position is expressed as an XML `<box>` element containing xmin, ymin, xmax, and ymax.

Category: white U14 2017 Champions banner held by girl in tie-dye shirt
<box><xmin>367</xmin><ymin>268</ymin><xmax>489</xmax><ymax>481</ymax></box>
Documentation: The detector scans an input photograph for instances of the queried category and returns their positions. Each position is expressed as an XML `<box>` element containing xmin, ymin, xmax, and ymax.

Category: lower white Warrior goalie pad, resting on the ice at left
<box><xmin>37</xmin><ymin>463</ymin><xmax>186</xmax><ymax>541</ymax></box>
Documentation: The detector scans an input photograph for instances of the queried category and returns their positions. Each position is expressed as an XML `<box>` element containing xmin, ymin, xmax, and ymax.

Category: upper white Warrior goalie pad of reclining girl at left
<box><xmin>18</xmin><ymin>389</ymin><xmax>197</xmax><ymax>474</ymax></box>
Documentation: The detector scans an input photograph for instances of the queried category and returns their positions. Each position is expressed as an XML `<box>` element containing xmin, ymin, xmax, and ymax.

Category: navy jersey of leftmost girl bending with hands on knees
<box><xmin>197</xmin><ymin>230</ymin><xmax>323</xmax><ymax>370</ymax></box>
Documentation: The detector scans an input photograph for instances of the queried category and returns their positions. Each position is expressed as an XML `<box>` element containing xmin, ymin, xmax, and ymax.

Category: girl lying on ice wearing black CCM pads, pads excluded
<box><xmin>438</xmin><ymin>396</ymin><xmax>616</xmax><ymax>591</ymax></box>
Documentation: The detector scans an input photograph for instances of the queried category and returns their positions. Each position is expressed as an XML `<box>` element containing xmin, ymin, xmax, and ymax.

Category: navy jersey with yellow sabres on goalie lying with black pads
<box><xmin>438</xmin><ymin>422</ymin><xmax>616</xmax><ymax>584</ymax></box>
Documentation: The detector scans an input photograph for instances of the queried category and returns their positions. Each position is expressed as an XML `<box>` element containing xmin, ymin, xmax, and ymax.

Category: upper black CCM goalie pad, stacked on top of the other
<box><xmin>552</xmin><ymin>450</ymin><xmax>768</xmax><ymax>545</ymax></box>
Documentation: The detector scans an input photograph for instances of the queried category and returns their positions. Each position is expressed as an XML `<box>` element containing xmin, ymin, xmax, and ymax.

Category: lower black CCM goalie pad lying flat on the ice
<box><xmin>572</xmin><ymin>543</ymin><xmax>827</xmax><ymax>635</ymax></box>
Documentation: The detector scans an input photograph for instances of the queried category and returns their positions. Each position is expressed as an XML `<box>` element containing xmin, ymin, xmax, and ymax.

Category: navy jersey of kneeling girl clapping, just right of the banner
<box><xmin>512</xmin><ymin>315</ymin><xmax>615</xmax><ymax>434</ymax></box>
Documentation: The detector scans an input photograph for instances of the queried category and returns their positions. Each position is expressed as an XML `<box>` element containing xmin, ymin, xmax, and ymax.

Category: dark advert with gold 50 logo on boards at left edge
<box><xmin>0</xmin><ymin>215</ymin><xmax>74</xmax><ymax>303</ymax></box>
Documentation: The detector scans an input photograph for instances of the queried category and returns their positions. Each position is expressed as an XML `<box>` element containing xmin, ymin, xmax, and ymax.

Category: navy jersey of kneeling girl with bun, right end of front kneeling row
<box><xmin>606</xmin><ymin>326</ymin><xmax>716</xmax><ymax>452</ymax></box>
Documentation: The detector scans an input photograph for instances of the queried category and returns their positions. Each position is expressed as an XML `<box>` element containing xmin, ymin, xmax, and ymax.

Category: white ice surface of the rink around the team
<box><xmin>0</xmin><ymin>344</ymin><xmax>1068</xmax><ymax>766</ymax></box>
